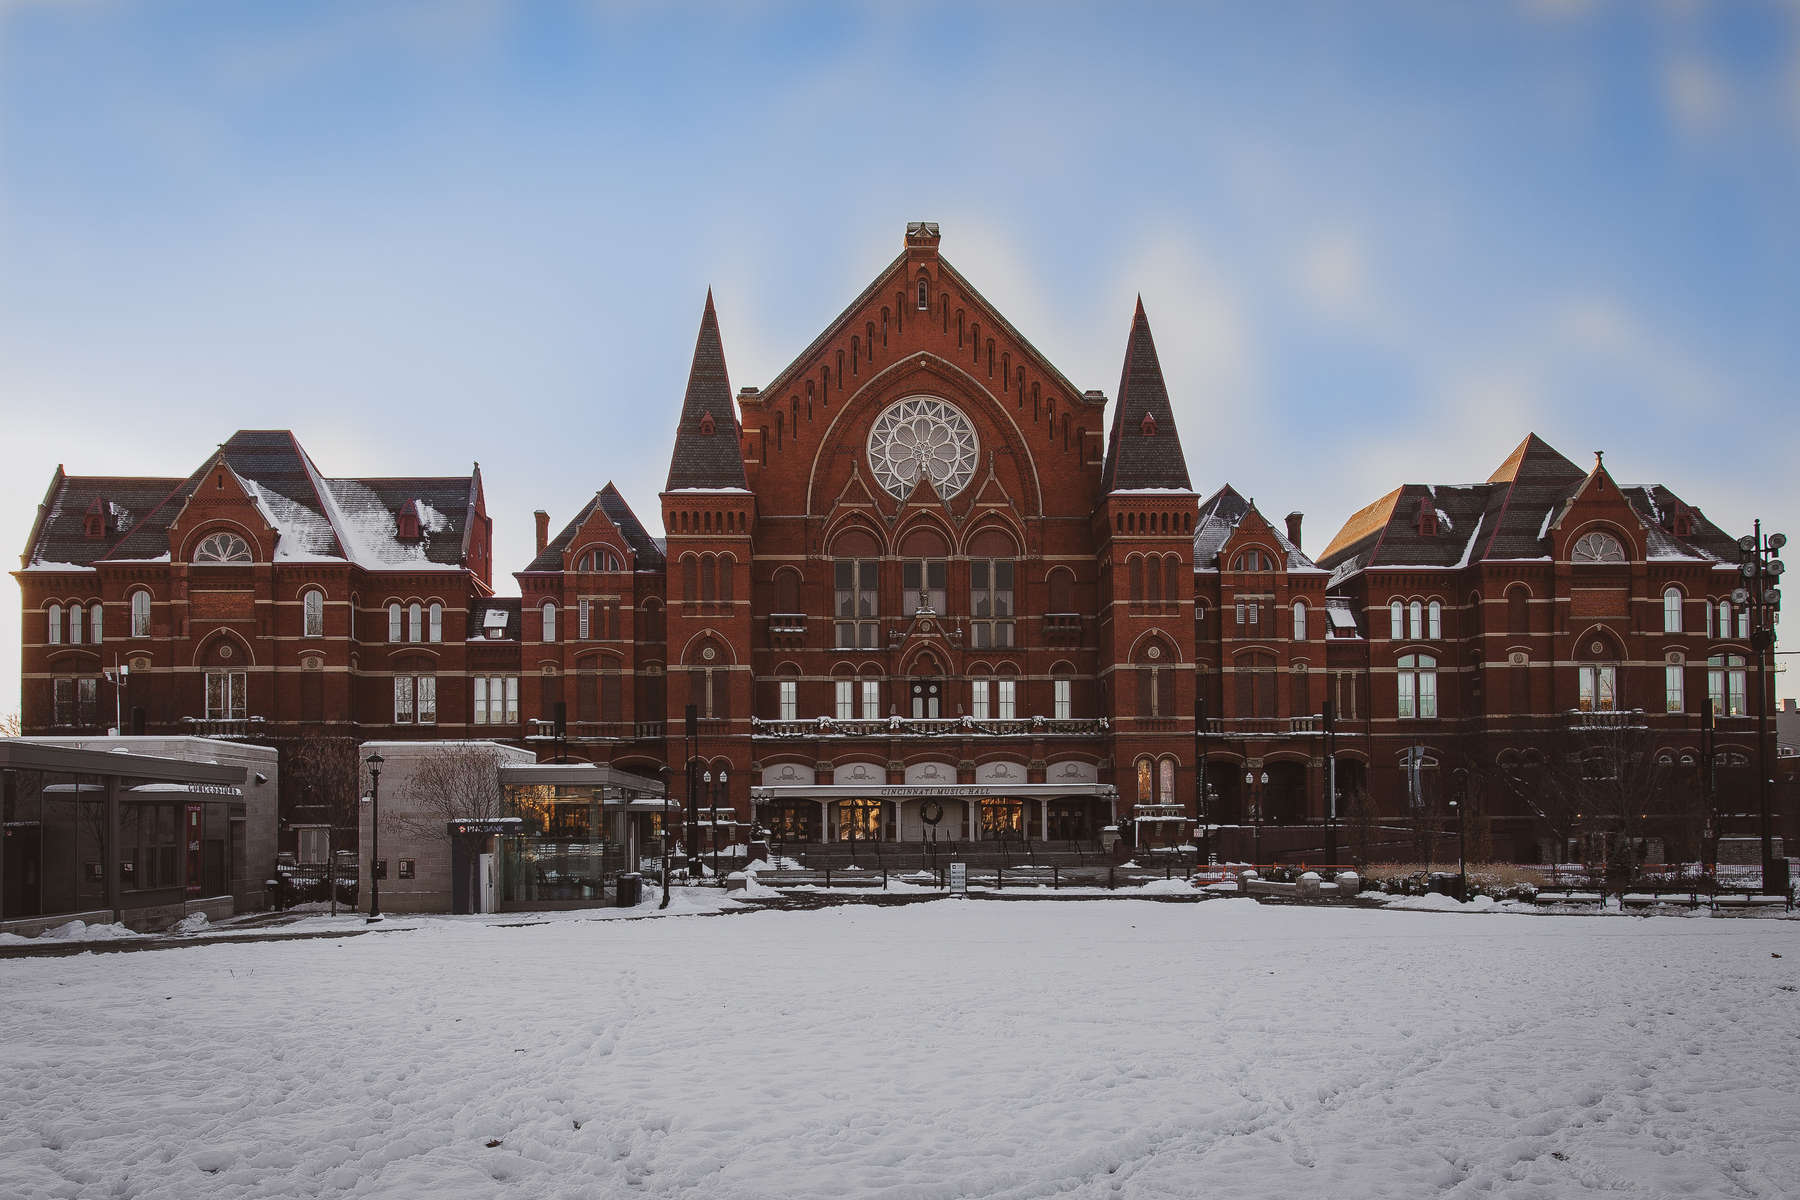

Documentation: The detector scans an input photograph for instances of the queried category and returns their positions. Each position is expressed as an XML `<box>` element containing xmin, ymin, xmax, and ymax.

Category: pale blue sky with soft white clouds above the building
<box><xmin>0</xmin><ymin>0</ymin><xmax>1800</xmax><ymax>712</ymax></box>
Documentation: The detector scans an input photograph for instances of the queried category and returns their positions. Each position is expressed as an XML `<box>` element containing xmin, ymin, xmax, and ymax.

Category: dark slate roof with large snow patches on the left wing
<box><xmin>23</xmin><ymin>430</ymin><xmax>479</xmax><ymax>570</ymax></box>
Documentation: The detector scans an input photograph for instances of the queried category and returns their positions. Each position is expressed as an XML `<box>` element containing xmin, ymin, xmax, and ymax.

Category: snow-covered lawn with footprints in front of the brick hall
<box><xmin>0</xmin><ymin>900</ymin><xmax>1800</xmax><ymax>1200</ymax></box>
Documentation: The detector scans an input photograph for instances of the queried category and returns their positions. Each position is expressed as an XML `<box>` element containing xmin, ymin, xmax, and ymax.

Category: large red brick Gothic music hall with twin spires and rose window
<box><xmin>18</xmin><ymin>223</ymin><xmax>1773</xmax><ymax>860</ymax></box>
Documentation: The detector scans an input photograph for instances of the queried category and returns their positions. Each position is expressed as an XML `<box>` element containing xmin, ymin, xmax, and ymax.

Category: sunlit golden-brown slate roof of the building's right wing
<box><xmin>1319</xmin><ymin>434</ymin><xmax>1735</xmax><ymax>583</ymax></box>
